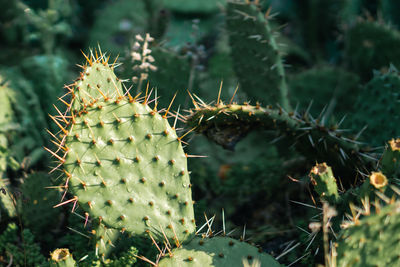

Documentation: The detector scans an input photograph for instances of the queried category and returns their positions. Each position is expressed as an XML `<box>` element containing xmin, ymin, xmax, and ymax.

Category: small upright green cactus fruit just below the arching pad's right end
<box><xmin>310</xmin><ymin>163</ymin><xmax>339</xmax><ymax>203</ymax></box>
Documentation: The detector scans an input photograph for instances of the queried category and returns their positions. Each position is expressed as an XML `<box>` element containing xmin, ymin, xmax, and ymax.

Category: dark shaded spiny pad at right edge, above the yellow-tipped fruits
<box><xmin>349</xmin><ymin>66</ymin><xmax>400</xmax><ymax>146</ymax></box>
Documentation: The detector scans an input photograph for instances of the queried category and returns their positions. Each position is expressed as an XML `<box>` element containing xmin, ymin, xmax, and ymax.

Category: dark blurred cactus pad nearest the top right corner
<box><xmin>345</xmin><ymin>21</ymin><xmax>400</xmax><ymax>81</ymax></box>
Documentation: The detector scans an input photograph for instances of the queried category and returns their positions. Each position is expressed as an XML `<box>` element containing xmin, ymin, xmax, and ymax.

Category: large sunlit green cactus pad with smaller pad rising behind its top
<box><xmin>52</xmin><ymin>51</ymin><xmax>195</xmax><ymax>245</ymax></box>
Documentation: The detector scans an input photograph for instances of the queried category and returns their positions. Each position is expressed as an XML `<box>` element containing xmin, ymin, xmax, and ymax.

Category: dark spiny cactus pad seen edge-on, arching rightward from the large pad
<box><xmin>185</xmin><ymin>103</ymin><xmax>372</xmax><ymax>178</ymax></box>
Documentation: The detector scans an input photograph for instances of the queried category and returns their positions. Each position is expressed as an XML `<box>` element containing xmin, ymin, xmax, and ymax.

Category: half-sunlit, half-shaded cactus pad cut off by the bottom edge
<box><xmin>158</xmin><ymin>237</ymin><xmax>281</xmax><ymax>267</ymax></box>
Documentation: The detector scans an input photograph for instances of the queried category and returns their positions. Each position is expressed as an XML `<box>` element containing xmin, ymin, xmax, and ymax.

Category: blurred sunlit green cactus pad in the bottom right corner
<box><xmin>337</xmin><ymin>201</ymin><xmax>400</xmax><ymax>267</ymax></box>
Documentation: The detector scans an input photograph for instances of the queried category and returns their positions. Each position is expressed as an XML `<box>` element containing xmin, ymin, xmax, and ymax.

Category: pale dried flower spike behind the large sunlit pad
<box><xmin>131</xmin><ymin>33</ymin><xmax>157</xmax><ymax>92</ymax></box>
